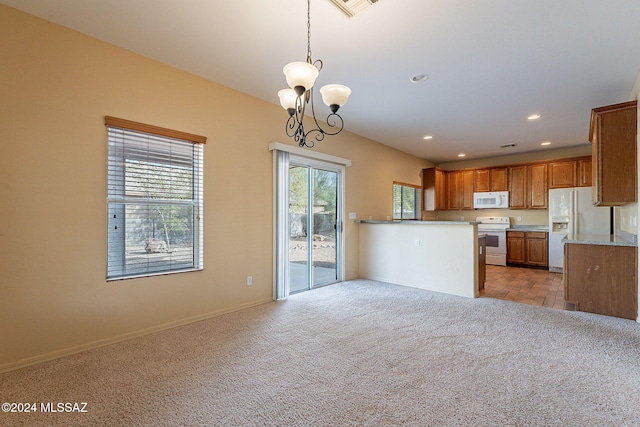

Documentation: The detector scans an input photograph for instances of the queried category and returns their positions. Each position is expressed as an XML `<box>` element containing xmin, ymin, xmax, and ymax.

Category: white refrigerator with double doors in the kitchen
<box><xmin>549</xmin><ymin>187</ymin><xmax>611</xmax><ymax>273</ymax></box>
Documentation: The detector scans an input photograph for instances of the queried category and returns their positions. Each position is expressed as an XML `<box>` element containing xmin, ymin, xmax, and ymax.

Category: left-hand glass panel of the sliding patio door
<box><xmin>289</xmin><ymin>166</ymin><xmax>310</xmax><ymax>293</ymax></box>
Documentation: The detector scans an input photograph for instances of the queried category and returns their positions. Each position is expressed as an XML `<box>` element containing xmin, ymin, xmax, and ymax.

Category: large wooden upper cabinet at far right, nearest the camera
<box><xmin>589</xmin><ymin>101</ymin><xmax>638</xmax><ymax>206</ymax></box>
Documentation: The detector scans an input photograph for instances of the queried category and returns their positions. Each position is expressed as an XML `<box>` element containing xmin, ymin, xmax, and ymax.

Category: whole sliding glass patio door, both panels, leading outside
<box><xmin>289</xmin><ymin>162</ymin><xmax>340</xmax><ymax>293</ymax></box>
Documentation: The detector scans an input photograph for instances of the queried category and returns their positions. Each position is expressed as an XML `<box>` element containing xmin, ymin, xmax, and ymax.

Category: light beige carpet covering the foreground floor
<box><xmin>0</xmin><ymin>281</ymin><xmax>640</xmax><ymax>426</ymax></box>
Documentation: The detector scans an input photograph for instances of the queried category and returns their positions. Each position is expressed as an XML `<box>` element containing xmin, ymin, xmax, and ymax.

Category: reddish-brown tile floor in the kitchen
<box><xmin>480</xmin><ymin>265</ymin><xmax>574</xmax><ymax>310</ymax></box>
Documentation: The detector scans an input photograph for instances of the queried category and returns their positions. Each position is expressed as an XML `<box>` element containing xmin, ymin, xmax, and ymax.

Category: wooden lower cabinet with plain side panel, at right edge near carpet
<box><xmin>564</xmin><ymin>243</ymin><xmax>638</xmax><ymax>320</ymax></box>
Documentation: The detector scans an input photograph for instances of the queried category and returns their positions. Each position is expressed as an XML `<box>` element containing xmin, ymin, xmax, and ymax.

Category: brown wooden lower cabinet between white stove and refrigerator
<box><xmin>507</xmin><ymin>231</ymin><xmax>549</xmax><ymax>267</ymax></box>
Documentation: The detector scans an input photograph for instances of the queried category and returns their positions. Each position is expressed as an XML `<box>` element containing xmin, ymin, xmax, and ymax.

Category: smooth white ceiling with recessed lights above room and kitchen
<box><xmin>5</xmin><ymin>0</ymin><xmax>640</xmax><ymax>163</ymax></box>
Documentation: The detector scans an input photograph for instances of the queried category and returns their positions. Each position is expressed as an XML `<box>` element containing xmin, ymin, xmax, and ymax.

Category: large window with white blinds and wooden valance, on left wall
<box><xmin>105</xmin><ymin>117</ymin><xmax>206</xmax><ymax>280</ymax></box>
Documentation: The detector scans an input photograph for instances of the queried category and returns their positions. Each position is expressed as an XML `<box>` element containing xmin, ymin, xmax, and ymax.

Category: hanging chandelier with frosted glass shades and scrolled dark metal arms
<box><xmin>278</xmin><ymin>0</ymin><xmax>351</xmax><ymax>148</ymax></box>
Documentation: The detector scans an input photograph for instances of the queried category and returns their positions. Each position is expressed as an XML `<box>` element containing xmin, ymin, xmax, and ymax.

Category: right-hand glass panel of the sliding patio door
<box><xmin>309</xmin><ymin>169</ymin><xmax>338</xmax><ymax>286</ymax></box>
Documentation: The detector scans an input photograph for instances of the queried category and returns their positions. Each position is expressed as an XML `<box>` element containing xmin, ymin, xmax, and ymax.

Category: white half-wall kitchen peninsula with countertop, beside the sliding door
<box><xmin>356</xmin><ymin>220</ymin><xmax>484</xmax><ymax>298</ymax></box>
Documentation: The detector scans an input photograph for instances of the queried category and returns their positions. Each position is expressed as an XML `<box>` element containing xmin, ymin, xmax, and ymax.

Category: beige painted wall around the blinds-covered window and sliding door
<box><xmin>0</xmin><ymin>5</ymin><xmax>431</xmax><ymax>371</ymax></box>
